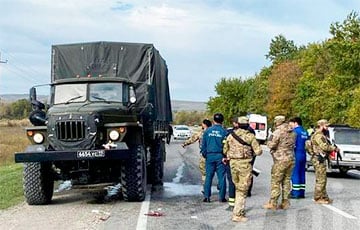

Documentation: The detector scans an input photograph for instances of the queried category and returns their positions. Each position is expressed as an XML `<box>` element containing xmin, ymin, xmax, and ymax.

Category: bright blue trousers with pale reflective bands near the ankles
<box><xmin>291</xmin><ymin>153</ymin><xmax>306</xmax><ymax>198</ymax></box>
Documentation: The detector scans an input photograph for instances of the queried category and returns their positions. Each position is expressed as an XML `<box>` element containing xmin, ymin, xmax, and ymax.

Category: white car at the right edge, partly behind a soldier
<box><xmin>306</xmin><ymin>125</ymin><xmax>360</xmax><ymax>174</ymax></box>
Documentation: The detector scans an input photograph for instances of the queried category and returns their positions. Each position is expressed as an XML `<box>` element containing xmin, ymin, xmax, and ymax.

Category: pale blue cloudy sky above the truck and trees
<box><xmin>0</xmin><ymin>0</ymin><xmax>360</xmax><ymax>102</ymax></box>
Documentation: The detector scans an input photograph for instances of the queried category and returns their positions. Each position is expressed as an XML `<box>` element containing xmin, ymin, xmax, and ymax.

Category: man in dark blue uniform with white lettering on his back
<box><xmin>201</xmin><ymin>113</ymin><xmax>227</xmax><ymax>202</ymax></box>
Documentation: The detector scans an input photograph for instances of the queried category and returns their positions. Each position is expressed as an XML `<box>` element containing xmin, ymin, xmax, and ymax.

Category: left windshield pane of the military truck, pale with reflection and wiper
<box><xmin>54</xmin><ymin>84</ymin><xmax>86</xmax><ymax>104</ymax></box>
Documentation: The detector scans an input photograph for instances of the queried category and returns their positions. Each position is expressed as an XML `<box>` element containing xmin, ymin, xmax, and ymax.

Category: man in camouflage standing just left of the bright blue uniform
<box><xmin>263</xmin><ymin>116</ymin><xmax>295</xmax><ymax>210</ymax></box>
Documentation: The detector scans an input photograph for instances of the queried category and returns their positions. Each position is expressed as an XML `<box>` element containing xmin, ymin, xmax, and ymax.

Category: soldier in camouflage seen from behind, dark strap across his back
<box><xmin>223</xmin><ymin>117</ymin><xmax>262</xmax><ymax>222</ymax></box>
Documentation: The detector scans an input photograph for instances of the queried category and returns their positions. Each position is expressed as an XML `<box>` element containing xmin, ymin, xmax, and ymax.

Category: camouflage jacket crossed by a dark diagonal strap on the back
<box><xmin>223</xmin><ymin>129</ymin><xmax>262</xmax><ymax>159</ymax></box>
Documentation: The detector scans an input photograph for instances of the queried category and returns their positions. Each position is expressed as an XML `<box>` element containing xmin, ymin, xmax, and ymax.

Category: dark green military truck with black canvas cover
<box><xmin>15</xmin><ymin>42</ymin><xmax>172</xmax><ymax>205</ymax></box>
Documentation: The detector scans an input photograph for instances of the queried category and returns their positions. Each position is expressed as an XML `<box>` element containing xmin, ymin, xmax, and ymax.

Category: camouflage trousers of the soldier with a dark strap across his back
<box><xmin>230</xmin><ymin>159</ymin><xmax>252</xmax><ymax>216</ymax></box>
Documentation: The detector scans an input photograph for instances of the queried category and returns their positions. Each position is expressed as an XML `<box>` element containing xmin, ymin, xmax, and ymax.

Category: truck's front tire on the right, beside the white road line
<box><xmin>121</xmin><ymin>145</ymin><xmax>146</xmax><ymax>201</ymax></box>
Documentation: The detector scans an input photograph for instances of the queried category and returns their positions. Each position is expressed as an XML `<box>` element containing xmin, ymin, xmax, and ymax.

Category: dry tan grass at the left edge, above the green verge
<box><xmin>0</xmin><ymin>120</ymin><xmax>30</xmax><ymax>166</ymax></box>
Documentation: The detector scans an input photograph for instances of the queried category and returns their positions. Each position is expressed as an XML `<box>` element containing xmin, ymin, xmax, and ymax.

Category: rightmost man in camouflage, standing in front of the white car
<box><xmin>311</xmin><ymin>119</ymin><xmax>339</xmax><ymax>204</ymax></box>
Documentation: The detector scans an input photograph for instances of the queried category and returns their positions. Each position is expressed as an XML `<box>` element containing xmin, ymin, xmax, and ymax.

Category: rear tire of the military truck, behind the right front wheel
<box><xmin>149</xmin><ymin>139</ymin><xmax>165</xmax><ymax>185</ymax></box>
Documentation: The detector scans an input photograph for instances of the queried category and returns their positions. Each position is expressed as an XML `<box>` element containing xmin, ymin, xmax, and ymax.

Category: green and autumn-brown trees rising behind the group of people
<box><xmin>207</xmin><ymin>11</ymin><xmax>360</xmax><ymax>127</ymax></box>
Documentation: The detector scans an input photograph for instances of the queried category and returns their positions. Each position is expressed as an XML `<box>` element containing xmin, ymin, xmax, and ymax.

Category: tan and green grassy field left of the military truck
<box><xmin>0</xmin><ymin>121</ymin><xmax>29</xmax><ymax>209</ymax></box>
